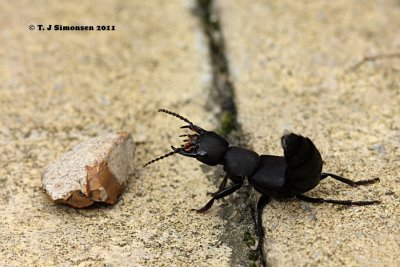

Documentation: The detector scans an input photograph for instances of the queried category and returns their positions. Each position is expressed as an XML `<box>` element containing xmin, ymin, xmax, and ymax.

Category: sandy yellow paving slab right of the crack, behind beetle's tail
<box><xmin>218</xmin><ymin>0</ymin><xmax>400</xmax><ymax>266</ymax></box>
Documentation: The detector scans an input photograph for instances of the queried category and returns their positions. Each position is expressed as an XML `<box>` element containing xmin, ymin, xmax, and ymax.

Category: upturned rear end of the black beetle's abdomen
<box><xmin>281</xmin><ymin>133</ymin><xmax>322</xmax><ymax>194</ymax></box>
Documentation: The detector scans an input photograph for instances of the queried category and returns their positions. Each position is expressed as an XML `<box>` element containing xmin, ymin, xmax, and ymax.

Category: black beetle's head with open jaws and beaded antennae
<box><xmin>144</xmin><ymin>109</ymin><xmax>229</xmax><ymax>166</ymax></box>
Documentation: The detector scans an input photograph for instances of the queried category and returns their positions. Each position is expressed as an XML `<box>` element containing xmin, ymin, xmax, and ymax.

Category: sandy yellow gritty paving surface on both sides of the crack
<box><xmin>0</xmin><ymin>0</ymin><xmax>400</xmax><ymax>266</ymax></box>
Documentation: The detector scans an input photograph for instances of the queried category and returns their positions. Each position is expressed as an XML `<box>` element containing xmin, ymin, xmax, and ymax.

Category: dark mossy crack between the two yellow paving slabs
<box><xmin>194</xmin><ymin>0</ymin><xmax>266</xmax><ymax>266</ymax></box>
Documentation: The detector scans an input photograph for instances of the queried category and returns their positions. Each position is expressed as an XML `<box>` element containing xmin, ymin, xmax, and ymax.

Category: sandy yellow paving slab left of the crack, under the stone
<box><xmin>0</xmin><ymin>0</ymin><xmax>231</xmax><ymax>266</ymax></box>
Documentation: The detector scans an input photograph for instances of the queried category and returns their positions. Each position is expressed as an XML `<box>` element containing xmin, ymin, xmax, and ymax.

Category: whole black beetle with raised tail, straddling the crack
<box><xmin>144</xmin><ymin>109</ymin><xmax>380</xmax><ymax>253</ymax></box>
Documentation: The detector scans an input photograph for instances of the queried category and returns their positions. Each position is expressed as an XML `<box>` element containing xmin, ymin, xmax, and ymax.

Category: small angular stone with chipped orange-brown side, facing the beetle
<box><xmin>42</xmin><ymin>131</ymin><xmax>135</xmax><ymax>208</ymax></box>
